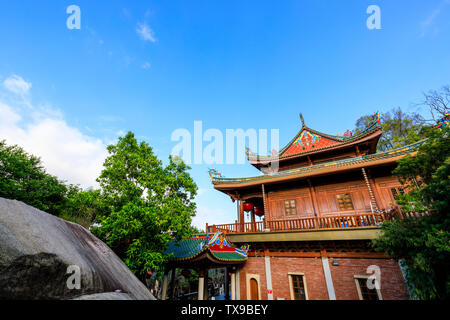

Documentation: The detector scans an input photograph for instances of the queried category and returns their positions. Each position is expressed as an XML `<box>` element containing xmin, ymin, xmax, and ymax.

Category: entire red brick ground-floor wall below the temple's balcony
<box><xmin>239</xmin><ymin>257</ymin><xmax>408</xmax><ymax>300</ymax></box>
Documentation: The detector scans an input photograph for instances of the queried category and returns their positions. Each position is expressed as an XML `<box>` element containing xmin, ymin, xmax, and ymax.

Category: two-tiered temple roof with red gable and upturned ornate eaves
<box><xmin>210</xmin><ymin>113</ymin><xmax>422</xmax><ymax>195</ymax></box>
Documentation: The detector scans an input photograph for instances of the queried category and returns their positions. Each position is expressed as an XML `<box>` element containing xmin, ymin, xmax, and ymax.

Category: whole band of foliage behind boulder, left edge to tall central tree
<box><xmin>0</xmin><ymin>141</ymin><xmax>105</xmax><ymax>227</ymax></box>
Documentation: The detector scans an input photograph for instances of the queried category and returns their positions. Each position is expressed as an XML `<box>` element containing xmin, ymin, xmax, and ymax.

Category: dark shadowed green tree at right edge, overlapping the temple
<box><xmin>374</xmin><ymin>127</ymin><xmax>450</xmax><ymax>299</ymax></box>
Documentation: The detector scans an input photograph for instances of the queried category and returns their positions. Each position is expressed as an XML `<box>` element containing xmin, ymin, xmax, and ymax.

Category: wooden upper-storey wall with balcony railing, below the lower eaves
<box><xmin>208</xmin><ymin>166</ymin><xmax>428</xmax><ymax>238</ymax></box>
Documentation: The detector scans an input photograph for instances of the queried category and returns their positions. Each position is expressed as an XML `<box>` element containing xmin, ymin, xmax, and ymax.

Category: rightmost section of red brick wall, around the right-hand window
<box><xmin>329</xmin><ymin>258</ymin><xmax>408</xmax><ymax>300</ymax></box>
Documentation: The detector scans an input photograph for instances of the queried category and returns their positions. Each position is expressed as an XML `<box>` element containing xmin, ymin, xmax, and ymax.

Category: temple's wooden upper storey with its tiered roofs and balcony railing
<box><xmin>208</xmin><ymin>114</ymin><xmax>423</xmax><ymax>239</ymax></box>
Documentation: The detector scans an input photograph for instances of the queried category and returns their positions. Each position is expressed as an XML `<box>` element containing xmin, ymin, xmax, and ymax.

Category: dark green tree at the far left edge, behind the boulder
<box><xmin>0</xmin><ymin>140</ymin><xmax>67</xmax><ymax>215</ymax></box>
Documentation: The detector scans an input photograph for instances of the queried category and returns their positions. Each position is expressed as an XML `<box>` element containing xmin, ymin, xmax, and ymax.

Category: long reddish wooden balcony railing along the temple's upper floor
<box><xmin>207</xmin><ymin>211</ymin><xmax>429</xmax><ymax>233</ymax></box>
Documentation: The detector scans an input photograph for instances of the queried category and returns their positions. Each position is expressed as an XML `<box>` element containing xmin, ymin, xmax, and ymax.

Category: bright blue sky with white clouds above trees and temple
<box><xmin>0</xmin><ymin>0</ymin><xmax>450</xmax><ymax>226</ymax></box>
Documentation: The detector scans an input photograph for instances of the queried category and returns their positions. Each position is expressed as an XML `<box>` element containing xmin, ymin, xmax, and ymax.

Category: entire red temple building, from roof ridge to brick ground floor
<box><xmin>166</xmin><ymin>114</ymin><xmax>420</xmax><ymax>300</ymax></box>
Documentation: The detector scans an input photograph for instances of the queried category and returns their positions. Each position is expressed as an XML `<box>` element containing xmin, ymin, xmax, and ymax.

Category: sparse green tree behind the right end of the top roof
<box><xmin>355</xmin><ymin>108</ymin><xmax>424</xmax><ymax>151</ymax></box>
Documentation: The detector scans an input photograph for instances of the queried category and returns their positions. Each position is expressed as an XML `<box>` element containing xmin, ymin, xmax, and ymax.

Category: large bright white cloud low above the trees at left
<box><xmin>0</xmin><ymin>77</ymin><xmax>107</xmax><ymax>188</ymax></box>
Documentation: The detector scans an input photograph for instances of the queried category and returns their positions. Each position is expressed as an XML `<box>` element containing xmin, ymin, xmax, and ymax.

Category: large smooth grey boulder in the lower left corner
<box><xmin>0</xmin><ymin>198</ymin><xmax>155</xmax><ymax>300</ymax></box>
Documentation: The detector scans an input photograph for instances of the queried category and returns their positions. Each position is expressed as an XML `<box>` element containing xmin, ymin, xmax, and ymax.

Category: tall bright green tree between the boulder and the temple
<box><xmin>93</xmin><ymin>132</ymin><xmax>197</xmax><ymax>276</ymax></box>
